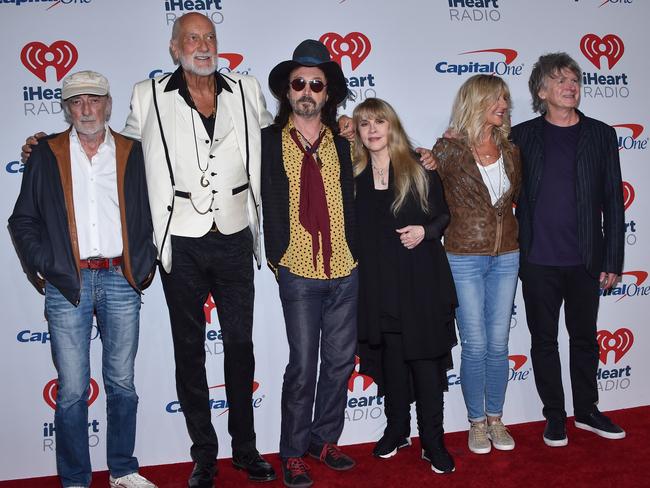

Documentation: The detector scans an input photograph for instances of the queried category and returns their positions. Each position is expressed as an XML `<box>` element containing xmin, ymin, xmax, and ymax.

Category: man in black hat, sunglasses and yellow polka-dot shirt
<box><xmin>262</xmin><ymin>39</ymin><xmax>358</xmax><ymax>487</ymax></box>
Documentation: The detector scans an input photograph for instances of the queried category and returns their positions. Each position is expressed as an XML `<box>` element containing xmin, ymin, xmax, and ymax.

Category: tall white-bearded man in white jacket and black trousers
<box><xmin>123</xmin><ymin>13</ymin><xmax>275</xmax><ymax>487</ymax></box>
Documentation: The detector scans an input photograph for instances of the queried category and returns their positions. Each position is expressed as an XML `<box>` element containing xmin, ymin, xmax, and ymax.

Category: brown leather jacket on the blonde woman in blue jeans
<box><xmin>433</xmin><ymin>139</ymin><xmax>521</xmax><ymax>256</ymax></box>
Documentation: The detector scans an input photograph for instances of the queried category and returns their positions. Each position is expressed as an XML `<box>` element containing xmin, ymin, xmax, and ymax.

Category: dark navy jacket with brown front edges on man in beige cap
<box><xmin>9</xmin><ymin>129</ymin><xmax>156</xmax><ymax>305</ymax></box>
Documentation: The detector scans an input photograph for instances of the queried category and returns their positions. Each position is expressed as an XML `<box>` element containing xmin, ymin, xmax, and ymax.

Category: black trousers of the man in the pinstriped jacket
<box><xmin>519</xmin><ymin>263</ymin><xmax>599</xmax><ymax>420</ymax></box>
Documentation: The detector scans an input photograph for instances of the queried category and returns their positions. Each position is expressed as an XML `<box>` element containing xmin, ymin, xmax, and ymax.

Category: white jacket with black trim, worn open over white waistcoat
<box><xmin>122</xmin><ymin>73</ymin><xmax>272</xmax><ymax>272</ymax></box>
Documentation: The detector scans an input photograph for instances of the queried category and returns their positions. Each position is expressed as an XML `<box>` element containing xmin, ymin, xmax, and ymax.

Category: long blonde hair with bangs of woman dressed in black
<box><xmin>352</xmin><ymin>98</ymin><xmax>429</xmax><ymax>215</ymax></box>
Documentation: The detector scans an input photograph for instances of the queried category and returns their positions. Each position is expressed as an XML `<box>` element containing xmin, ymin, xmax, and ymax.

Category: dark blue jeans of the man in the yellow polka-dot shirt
<box><xmin>279</xmin><ymin>267</ymin><xmax>359</xmax><ymax>458</ymax></box>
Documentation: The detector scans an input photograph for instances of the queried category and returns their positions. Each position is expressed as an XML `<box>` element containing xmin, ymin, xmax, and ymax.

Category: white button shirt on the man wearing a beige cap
<box><xmin>70</xmin><ymin>126</ymin><xmax>122</xmax><ymax>259</ymax></box>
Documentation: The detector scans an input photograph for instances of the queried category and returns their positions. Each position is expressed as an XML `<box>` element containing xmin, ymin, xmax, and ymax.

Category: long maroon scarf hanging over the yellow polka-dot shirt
<box><xmin>289</xmin><ymin>128</ymin><xmax>332</xmax><ymax>278</ymax></box>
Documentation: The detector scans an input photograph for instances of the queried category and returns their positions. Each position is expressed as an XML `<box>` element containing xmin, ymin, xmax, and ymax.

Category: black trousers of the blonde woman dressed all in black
<box><xmin>382</xmin><ymin>332</ymin><xmax>445</xmax><ymax>449</ymax></box>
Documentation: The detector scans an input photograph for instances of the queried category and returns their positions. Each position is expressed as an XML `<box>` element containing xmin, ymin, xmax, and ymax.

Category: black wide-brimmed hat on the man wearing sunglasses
<box><xmin>269</xmin><ymin>39</ymin><xmax>348</xmax><ymax>105</ymax></box>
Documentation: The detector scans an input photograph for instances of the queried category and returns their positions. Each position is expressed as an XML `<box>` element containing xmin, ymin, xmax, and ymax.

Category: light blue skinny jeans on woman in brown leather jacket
<box><xmin>447</xmin><ymin>251</ymin><xmax>519</xmax><ymax>422</ymax></box>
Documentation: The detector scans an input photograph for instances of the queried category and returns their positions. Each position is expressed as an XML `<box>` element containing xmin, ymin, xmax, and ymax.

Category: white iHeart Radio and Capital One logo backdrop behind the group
<box><xmin>0</xmin><ymin>0</ymin><xmax>650</xmax><ymax>479</ymax></box>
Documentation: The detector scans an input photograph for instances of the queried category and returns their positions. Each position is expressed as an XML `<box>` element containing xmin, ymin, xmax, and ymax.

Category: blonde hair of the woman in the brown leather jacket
<box><xmin>449</xmin><ymin>75</ymin><xmax>512</xmax><ymax>150</ymax></box>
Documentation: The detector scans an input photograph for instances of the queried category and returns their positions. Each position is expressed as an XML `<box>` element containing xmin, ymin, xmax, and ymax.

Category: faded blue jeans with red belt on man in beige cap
<box><xmin>45</xmin><ymin>267</ymin><xmax>140</xmax><ymax>487</ymax></box>
